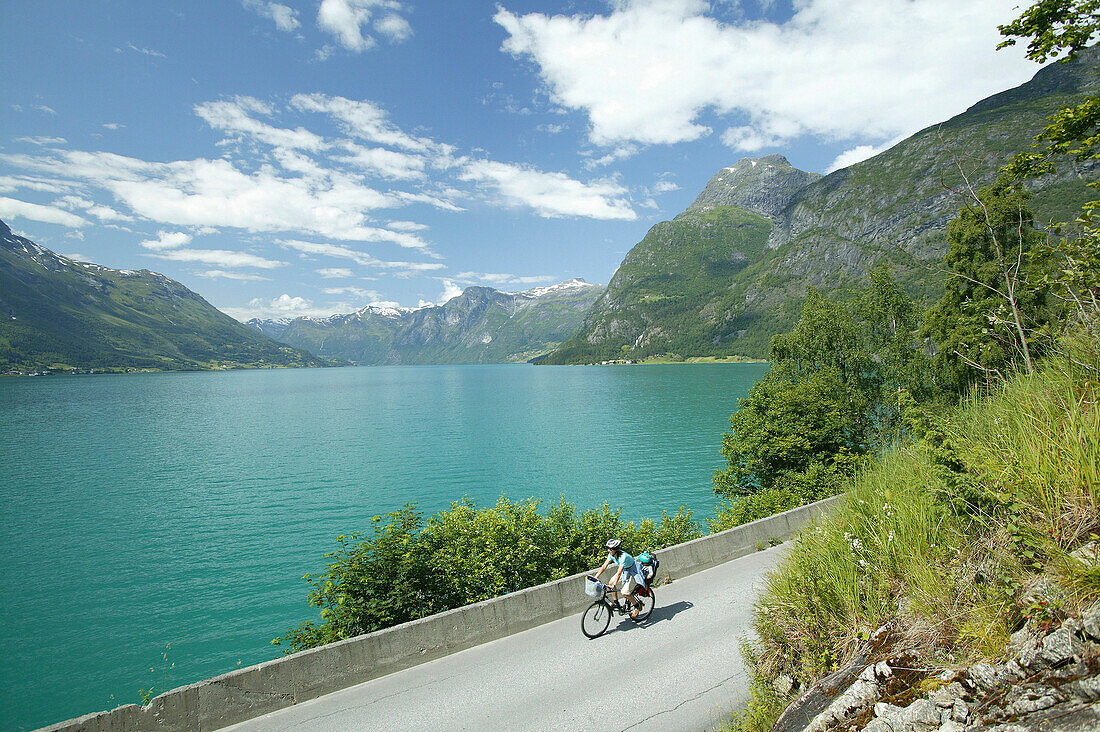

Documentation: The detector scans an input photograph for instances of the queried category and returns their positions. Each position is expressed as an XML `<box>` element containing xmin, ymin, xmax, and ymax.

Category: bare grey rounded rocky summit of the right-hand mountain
<box><xmin>688</xmin><ymin>154</ymin><xmax>822</xmax><ymax>217</ymax></box>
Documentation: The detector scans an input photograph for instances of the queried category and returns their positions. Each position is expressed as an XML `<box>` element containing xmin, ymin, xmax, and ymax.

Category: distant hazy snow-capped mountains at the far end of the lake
<box><xmin>249</xmin><ymin>280</ymin><xmax>604</xmax><ymax>365</ymax></box>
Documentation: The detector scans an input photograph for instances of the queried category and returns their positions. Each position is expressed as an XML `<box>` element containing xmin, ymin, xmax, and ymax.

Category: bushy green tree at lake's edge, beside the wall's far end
<box><xmin>714</xmin><ymin>268</ymin><xmax>931</xmax><ymax>501</ymax></box>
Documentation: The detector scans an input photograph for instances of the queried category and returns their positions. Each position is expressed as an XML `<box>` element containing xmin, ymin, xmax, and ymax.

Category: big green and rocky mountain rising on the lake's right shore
<box><xmin>541</xmin><ymin>48</ymin><xmax>1100</xmax><ymax>363</ymax></box>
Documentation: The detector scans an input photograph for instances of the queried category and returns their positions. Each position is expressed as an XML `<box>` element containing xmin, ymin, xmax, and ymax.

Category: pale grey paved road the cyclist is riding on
<box><xmin>228</xmin><ymin>546</ymin><xmax>784</xmax><ymax>732</ymax></box>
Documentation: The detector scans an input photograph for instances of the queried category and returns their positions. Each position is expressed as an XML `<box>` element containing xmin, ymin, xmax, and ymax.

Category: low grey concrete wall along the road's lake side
<box><xmin>44</xmin><ymin>496</ymin><xmax>843</xmax><ymax>732</ymax></box>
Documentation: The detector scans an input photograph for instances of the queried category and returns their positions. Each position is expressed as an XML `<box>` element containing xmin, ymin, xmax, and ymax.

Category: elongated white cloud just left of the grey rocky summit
<box><xmin>460</xmin><ymin>161</ymin><xmax>638</xmax><ymax>221</ymax></box>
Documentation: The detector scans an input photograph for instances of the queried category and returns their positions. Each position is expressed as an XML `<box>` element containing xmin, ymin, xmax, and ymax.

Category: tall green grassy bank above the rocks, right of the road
<box><xmin>735</xmin><ymin>343</ymin><xmax>1100</xmax><ymax>730</ymax></box>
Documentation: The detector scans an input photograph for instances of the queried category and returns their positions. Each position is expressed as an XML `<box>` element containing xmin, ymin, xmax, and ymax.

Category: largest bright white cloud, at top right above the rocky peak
<box><xmin>495</xmin><ymin>0</ymin><xmax>1035</xmax><ymax>150</ymax></box>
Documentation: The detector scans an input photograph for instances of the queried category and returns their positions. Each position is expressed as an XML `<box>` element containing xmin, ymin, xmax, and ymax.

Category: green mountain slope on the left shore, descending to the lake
<box><xmin>0</xmin><ymin>221</ymin><xmax>323</xmax><ymax>371</ymax></box>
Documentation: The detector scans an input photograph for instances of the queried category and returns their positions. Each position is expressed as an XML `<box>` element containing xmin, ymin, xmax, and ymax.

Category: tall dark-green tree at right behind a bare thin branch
<box><xmin>922</xmin><ymin>176</ymin><xmax>1047</xmax><ymax>391</ymax></box>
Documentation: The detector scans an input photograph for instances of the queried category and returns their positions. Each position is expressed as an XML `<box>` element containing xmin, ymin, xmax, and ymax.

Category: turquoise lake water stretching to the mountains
<box><xmin>0</xmin><ymin>364</ymin><xmax>768</xmax><ymax>729</ymax></box>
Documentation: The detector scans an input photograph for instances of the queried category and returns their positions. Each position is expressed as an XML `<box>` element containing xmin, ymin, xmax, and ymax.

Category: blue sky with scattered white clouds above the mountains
<box><xmin>0</xmin><ymin>0</ymin><xmax>1037</xmax><ymax>319</ymax></box>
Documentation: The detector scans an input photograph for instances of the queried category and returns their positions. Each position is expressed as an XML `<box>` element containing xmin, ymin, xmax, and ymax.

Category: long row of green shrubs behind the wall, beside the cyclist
<box><xmin>273</xmin><ymin>496</ymin><xmax>702</xmax><ymax>653</ymax></box>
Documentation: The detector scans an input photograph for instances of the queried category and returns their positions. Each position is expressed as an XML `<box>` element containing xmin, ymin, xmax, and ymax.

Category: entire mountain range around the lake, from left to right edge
<box><xmin>0</xmin><ymin>46</ymin><xmax>1100</xmax><ymax>372</ymax></box>
